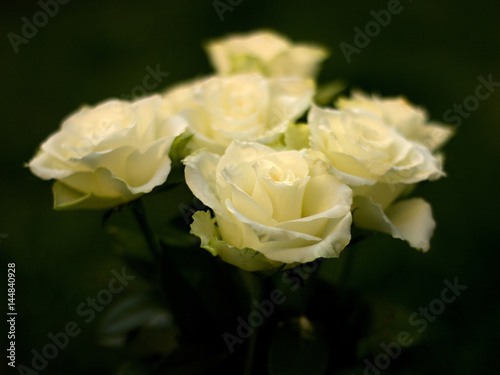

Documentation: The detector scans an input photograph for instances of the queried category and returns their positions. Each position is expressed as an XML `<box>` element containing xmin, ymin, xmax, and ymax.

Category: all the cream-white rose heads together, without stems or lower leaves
<box><xmin>29</xmin><ymin>31</ymin><xmax>452</xmax><ymax>271</ymax></box>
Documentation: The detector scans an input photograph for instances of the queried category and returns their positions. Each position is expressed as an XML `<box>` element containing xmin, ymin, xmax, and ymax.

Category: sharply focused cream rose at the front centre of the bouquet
<box><xmin>185</xmin><ymin>141</ymin><xmax>352</xmax><ymax>271</ymax></box>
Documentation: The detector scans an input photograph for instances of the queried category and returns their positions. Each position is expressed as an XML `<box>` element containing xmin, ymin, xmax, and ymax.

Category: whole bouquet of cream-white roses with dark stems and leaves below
<box><xmin>29</xmin><ymin>31</ymin><xmax>452</xmax><ymax>374</ymax></box>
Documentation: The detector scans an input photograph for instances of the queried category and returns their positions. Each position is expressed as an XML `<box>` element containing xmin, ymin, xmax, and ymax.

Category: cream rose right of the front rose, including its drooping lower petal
<box><xmin>309</xmin><ymin>107</ymin><xmax>444</xmax><ymax>250</ymax></box>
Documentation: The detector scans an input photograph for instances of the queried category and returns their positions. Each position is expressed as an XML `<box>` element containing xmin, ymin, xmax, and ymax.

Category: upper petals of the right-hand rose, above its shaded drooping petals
<box><xmin>309</xmin><ymin>106</ymin><xmax>444</xmax><ymax>186</ymax></box>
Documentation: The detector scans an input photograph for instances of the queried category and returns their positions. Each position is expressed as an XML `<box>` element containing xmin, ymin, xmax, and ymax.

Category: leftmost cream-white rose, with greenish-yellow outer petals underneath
<box><xmin>29</xmin><ymin>96</ymin><xmax>187</xmax><ymax>209</ymax></box>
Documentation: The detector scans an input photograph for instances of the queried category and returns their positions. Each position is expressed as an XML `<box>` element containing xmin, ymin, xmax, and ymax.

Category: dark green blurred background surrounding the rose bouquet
<box><xmin>0</xmin><ymin>0</ymin><xmax>500</xmax><ymax>375</ymax></box>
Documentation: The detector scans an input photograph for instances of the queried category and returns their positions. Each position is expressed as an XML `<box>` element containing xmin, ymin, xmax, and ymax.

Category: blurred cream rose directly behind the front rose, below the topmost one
<box><xmin>170</xmin><ymin>74</ymin><xmax>314</xmax><ymax>154</ymax></box>
